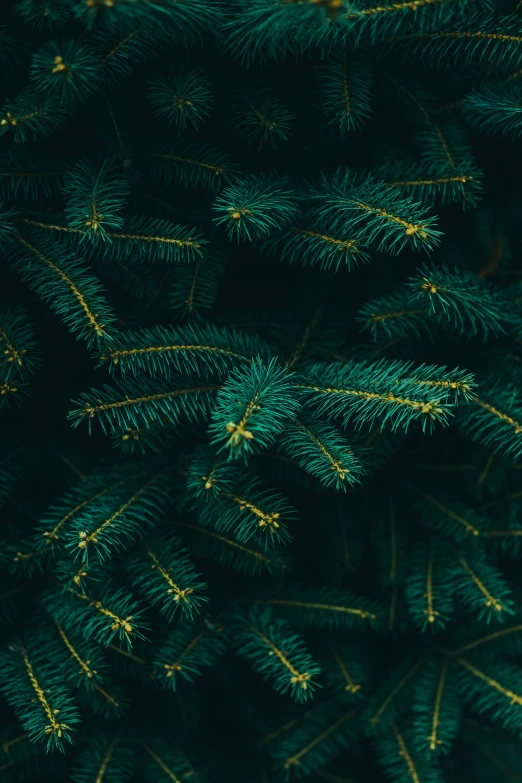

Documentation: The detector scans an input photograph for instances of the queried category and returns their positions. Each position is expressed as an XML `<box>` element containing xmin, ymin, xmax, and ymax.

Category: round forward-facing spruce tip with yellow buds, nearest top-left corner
<box><xmin>31</xmin><ymin>40</ymin><xmax>100</xmax><ymax>101</ymax></box>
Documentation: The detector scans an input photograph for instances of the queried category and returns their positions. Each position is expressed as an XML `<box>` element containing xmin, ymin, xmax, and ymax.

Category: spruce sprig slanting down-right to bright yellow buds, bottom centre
<box><xmin>232</xmin><ymin>610</ymin><xmax>321</xmax><ymax>701</ymax></box>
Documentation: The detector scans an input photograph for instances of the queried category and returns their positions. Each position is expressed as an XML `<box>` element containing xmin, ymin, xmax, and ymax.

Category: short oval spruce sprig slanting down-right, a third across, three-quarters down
<box><xmin>128</xmin><ymin>534</ymin><xmax>208</xmax><ymax>620</ymax></box>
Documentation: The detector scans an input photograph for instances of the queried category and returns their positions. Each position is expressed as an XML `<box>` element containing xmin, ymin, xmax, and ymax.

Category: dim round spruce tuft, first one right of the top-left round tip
<box><xmin>147</xmin><ymin>68</ymin><xmax>212</xmax><ymax>133</ymax></box>
